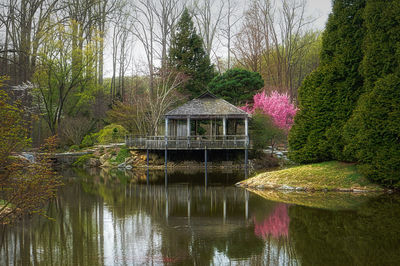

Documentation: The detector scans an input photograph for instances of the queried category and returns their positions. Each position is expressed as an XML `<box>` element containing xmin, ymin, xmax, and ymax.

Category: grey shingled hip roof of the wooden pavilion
<box><xmin>165</xmin><ymin>92</ymin><xmax>249</xmax><ymax>118</ymax></box>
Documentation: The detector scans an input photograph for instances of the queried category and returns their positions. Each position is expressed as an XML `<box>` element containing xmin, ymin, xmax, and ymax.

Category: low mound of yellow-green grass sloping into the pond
<box><xmin>237</xmin><ymin>161</ymin><xmax>383</xmax><ymax>191</ymax></box>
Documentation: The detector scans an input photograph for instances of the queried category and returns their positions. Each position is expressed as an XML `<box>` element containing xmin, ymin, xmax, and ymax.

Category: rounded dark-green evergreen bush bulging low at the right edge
<box><xmin>346</xmin><ymin>75</ymin><xmax>400</xmax><ymax>187</ymax></box>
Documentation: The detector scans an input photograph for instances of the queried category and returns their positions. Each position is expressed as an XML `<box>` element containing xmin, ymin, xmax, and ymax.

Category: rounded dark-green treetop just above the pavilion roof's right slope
<box><xmin>208</xmin><ymin>68</ymin><xmax>264</xmax><ymax>105</ymax></box>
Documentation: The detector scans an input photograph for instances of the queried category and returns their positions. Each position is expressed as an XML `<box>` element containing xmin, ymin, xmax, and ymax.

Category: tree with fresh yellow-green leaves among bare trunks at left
<box><xmin>32</xmin><ymin>20</ymin><xmax>101</xmax><ymax>135</ymax></box>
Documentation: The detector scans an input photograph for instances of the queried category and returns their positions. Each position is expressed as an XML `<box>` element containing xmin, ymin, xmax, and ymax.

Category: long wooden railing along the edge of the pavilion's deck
<box><xmin>125</xmin><ymin>135</ymin><xmax>250</xmax><ymax>150</ymax></box>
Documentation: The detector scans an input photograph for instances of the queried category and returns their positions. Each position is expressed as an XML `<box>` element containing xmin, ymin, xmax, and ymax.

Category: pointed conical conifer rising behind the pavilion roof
<box><xmin>169</xmin><ymin>9</ymin><xmax>215</xmax><ymax>98</ymax></box>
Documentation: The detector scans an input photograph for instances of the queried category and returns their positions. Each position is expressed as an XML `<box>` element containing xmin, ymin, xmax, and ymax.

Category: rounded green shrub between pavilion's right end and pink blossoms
<box><xmin>250</xmin><ymin>113</ymin><xmax>285</xmax><ymax>149</ymax></box>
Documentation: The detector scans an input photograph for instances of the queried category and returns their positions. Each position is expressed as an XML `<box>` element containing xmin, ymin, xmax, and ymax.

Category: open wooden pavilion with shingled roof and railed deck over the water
<box><xmin>126</xmin><ymin>92</ymin><xmax>249</xmax><ymax>150</ymax></box>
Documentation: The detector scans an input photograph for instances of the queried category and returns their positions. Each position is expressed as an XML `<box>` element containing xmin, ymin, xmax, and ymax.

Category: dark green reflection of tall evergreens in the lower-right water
<box><xmin>289</xmin><ymin>196</ymin><xmax>400</xmax><ymax>265</ymax></box>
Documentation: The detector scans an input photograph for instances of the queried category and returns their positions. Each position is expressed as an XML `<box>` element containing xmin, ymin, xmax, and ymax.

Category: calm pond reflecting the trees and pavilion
<box><xmin>0</xmin><ymin>169</ymin><xmax>400</xmax><ymax>265</ymax></box>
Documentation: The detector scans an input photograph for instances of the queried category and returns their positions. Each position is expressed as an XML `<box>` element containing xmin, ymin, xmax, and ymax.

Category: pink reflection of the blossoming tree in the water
<box><xmin>254</xmin><ymin>203</ymin><xmax>290</xmax><ymax>238</ymax></box>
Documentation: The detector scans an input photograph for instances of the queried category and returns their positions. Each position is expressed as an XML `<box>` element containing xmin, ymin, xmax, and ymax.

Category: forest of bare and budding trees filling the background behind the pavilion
<box><xmin>0</xmin><ymin>0</ymin><xmax>321</xmax><ymax>147</ymax></box>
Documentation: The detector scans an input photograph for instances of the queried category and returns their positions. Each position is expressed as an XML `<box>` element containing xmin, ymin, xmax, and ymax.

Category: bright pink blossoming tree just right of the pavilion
<box><xmin>242</xmin><ymin>91</ymin><xmax>297</xmax><ymax>133</ymax></box>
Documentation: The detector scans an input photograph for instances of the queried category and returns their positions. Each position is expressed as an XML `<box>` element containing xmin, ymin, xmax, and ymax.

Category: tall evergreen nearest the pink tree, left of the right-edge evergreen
<box><xmin>289</xmin><ymin>0</ymin><xmax>365</xmax><ymax>163</ymax></box>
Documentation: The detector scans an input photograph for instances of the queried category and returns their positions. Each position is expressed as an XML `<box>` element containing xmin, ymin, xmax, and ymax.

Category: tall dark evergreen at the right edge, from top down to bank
<box><xmin>344</xmin><ymin>0</ymin><xmax>400</xmax><ymax>187</ymax></box>
